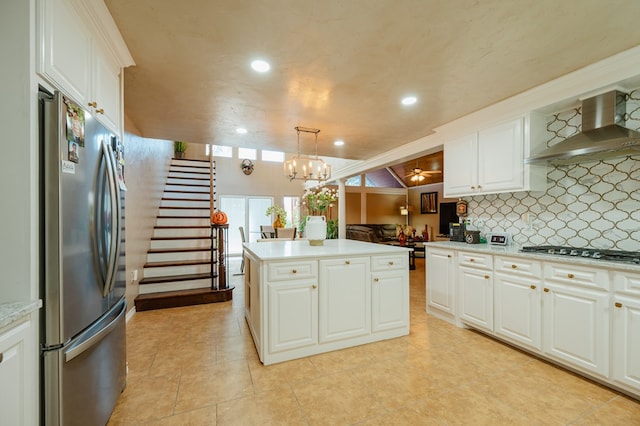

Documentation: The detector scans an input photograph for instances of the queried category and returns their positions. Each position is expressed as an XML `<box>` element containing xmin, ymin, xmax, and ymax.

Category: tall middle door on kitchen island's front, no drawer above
<box><xmin>319</xmin><ymin>257</ymin><xmax>371</xmax><ymax>343</ymax></box>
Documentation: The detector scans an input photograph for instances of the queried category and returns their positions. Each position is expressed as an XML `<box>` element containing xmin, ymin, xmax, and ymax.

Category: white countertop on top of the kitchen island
<box><xmin>244</xmin><ymin>239</ymin><xmax>410</xmax><ymax>260</ymax></box>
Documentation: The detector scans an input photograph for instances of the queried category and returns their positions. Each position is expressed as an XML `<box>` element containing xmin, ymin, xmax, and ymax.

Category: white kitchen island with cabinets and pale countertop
<box><xmin>244</xmin><ymin>239</ymin><xmax>409</xmax><ymax>365</ymax></box>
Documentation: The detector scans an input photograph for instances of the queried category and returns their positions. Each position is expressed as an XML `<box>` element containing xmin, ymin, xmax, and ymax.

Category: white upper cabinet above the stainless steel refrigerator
<box><xmin>37</xmin><ymin>0</ymin><xmax>133</xmax><ymax>134</ymax></box>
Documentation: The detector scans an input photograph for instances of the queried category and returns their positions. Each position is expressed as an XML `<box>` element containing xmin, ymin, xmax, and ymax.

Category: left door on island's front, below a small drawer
<box><xmin>267</xmin><ymin>280</ymin><xmax>318</xmax><ymax>353</ymax></box>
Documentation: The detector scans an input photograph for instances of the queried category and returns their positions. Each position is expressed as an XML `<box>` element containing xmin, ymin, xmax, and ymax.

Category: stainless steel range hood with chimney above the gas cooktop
<box><xmin>524</xmin><ymin>90</ymin><xmax>640</xmax><ymax>165</ymax></box>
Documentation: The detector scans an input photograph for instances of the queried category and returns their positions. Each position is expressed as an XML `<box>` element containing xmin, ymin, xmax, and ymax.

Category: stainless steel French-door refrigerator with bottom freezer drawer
<box><xmin>39</xmin><ymin>88</ymin><xmax>126</xmax><ymax>425</ymax></box>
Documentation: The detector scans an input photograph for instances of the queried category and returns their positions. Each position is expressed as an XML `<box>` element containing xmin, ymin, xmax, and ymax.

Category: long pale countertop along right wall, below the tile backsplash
<box><xmin>425</xmin><ymin>241</ymin><xmax>640</xmax><ymax>273</ymax></box>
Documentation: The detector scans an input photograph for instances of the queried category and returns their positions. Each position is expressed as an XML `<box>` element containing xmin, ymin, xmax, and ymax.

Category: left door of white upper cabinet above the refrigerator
<box><xmin>38</xmin><ymin>0</ymin><xmax>91</xmax><ymax>108</ymax></box>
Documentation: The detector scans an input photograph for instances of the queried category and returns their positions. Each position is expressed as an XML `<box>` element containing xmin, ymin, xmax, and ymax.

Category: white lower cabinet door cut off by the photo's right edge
<box><xmin>613</xmin><ymin>295</ymin><xmax>640</xmax><ymax>391</ymax></box>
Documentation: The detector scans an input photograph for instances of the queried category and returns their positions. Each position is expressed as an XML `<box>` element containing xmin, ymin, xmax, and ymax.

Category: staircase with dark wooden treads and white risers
<box><xmin>135</xmin><ymin>158</ymin><xmax>233</xmax><ymax>311</ymax></box>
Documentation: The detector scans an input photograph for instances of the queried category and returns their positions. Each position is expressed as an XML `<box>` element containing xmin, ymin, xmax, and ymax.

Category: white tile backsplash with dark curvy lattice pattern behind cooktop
<box><xmin>465</xmin><ymin>89</ymin><xmax>640</xmax><ymax>251</ymax></box>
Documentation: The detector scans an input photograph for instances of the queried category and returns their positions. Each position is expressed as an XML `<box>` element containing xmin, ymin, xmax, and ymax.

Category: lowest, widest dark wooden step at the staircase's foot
<box><xmin>135</xmin><ymin>286</ymin><xmax>235</xmax><ymax>311</ymax></box>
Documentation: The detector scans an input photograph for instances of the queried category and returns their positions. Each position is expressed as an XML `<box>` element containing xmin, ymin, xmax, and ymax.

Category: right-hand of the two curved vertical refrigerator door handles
<box><xmin>102</xmin><ymin>141</ymin><xmax>121</xmax><ymax>297</ymax></box>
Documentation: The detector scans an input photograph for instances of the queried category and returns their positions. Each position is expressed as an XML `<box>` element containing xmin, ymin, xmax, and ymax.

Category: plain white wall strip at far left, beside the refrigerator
<box><xmin>0</xmin><ymin>0</ymin><xmax>39</xmax><ymax>303</ymax></box>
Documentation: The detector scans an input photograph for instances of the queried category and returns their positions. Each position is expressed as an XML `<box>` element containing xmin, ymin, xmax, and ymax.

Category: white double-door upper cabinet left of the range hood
<box><xmin>444</xmin><ymin>114</ymin><xmax>546</xmax><ymax>197</ymax></box>
